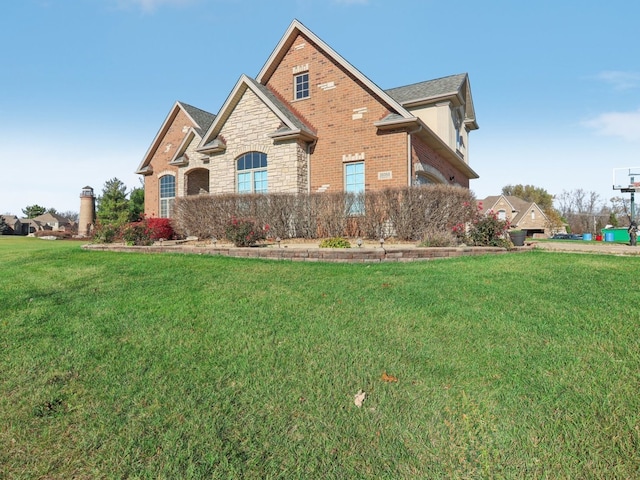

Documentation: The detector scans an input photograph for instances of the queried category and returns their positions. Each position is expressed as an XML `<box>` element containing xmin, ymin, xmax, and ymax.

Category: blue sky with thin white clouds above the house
<box><xmin>0</xmin><ymin>0</ymin><xmax>640</xmax><ymax>215</ymax></box>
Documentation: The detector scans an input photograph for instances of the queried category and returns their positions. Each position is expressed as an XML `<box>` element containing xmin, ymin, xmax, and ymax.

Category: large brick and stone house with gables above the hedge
<box><xmin>136</xmin><ymin>20</ymin><xmax>478</xmax><ymax>217</ymax></box>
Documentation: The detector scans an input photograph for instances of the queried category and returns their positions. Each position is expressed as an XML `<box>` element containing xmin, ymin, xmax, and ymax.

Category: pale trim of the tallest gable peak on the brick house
<box><xmin>256</xmin><ymin>19</ymin><xmax>415</xmax><ymax>120</ymax></box>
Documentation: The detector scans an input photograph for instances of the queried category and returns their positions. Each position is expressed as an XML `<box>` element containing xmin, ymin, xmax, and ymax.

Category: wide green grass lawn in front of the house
<box><xmin>0</xmin><ymin>236</ymin><xmax>640</xmax><ymax>479</ymax></box>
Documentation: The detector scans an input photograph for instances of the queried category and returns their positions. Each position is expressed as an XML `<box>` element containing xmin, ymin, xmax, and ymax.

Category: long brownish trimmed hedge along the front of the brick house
<box><xmin>173</xmin><ymin>185</ymin><xmax>477</xmax><ymax>241</ymax></box>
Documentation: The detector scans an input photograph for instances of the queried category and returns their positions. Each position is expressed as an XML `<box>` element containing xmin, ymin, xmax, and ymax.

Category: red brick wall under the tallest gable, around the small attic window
<box><xmin>267</xmin><ymin>31</ymin><xmax>407</xmax><ymax>192</ymax></box>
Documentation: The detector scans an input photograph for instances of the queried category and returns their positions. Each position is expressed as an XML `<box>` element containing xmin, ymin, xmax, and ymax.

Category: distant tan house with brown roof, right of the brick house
<box><xmin>478</xmin><ymin>195</ymin><xmax>551</xmax><ymax>237</ymax></box>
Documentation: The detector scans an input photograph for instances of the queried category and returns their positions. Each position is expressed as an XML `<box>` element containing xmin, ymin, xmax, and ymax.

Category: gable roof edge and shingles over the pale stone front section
<box><xmin>198</xmin><ymin>75</ymin><xmax>316</xmax><ymax>152</ymax></box>
